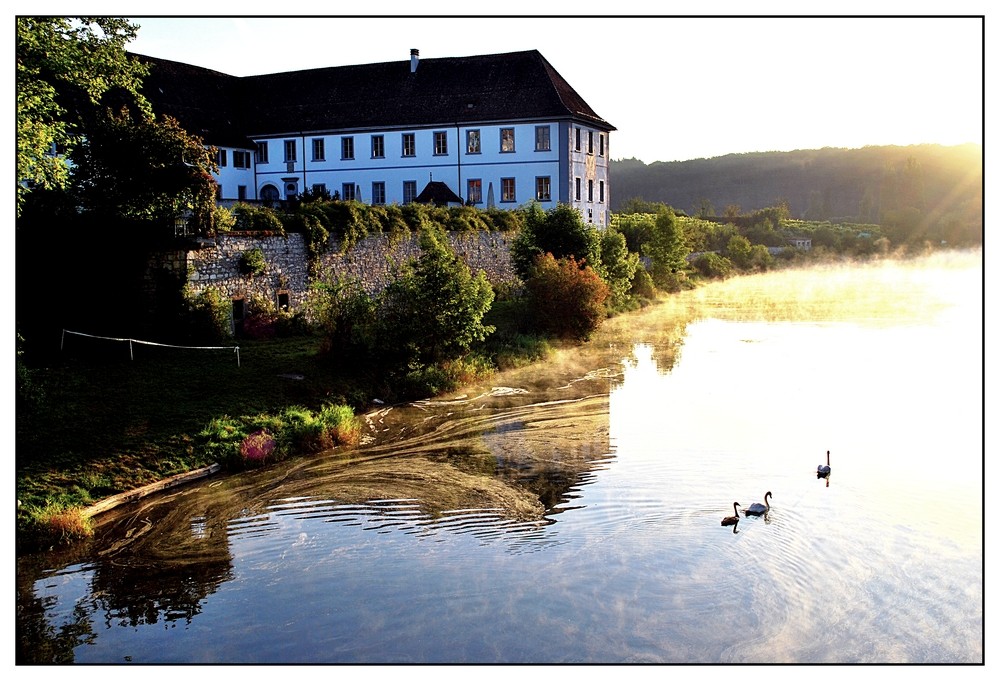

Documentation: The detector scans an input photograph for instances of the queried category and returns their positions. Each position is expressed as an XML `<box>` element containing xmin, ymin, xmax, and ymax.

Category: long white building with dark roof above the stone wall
<box><xmin>140</xmin><ymin>50</ymin><xmax>614</xmax><ymax>227</ymax></box>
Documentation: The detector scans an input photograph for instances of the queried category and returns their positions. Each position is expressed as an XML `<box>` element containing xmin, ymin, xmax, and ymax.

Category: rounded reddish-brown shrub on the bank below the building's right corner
<box><xmin>525</xmin><ymin>253</ymin><xmax>611</xmax><ymax>340</ymax></box>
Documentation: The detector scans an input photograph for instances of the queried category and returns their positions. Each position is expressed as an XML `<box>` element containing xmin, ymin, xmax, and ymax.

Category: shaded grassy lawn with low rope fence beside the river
<box><xmin>16</xmin><ymin>337</ymin><xmax>354</xmax><ymax>505</ymax></box>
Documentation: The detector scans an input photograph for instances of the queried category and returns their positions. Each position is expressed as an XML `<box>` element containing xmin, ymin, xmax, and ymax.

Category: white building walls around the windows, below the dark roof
<box><xmin>216</xmin><ymin>120</ymin><xmax>610</xmax><ymax>226</ymax></box>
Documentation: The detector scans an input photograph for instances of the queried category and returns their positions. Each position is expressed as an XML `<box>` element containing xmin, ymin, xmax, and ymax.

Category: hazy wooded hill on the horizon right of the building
<box><xmin>611</xmin><ymin>144</ymin><xmax>983</xmax><ymax>241</ymax></box>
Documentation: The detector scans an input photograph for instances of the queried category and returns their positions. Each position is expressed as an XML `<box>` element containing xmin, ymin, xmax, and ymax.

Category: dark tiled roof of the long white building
<box><xmin>133</xmin><ymin>50</ymin><xmax>614</xmax><ymax>144</ymax></box>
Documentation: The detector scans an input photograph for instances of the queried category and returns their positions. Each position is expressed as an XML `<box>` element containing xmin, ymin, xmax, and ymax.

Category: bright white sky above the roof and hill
<box><xmin>115</xmin><ymin>8</ymin><xmax>985</xmax><ymax>163</ymax></box>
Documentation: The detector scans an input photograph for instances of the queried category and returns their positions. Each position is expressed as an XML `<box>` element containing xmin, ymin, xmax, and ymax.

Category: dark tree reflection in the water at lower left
<box><xmin>16</xmin><ymin>498</ymin><xmax>238</xmax><ymax>664</ymax></box>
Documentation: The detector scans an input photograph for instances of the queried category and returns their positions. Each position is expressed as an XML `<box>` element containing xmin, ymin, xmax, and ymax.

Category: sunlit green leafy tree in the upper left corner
<box><xmin>15</xmin><ymin>17</ymin><xmax>148</xmax><ymax>214</ymax></box>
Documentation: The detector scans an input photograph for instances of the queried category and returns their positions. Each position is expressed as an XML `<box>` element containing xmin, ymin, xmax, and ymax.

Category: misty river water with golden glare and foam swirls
<box><xmin>17</xmin><ymin>252</ymin><xmax>984</xmax><ymax>664</ymax></box>
